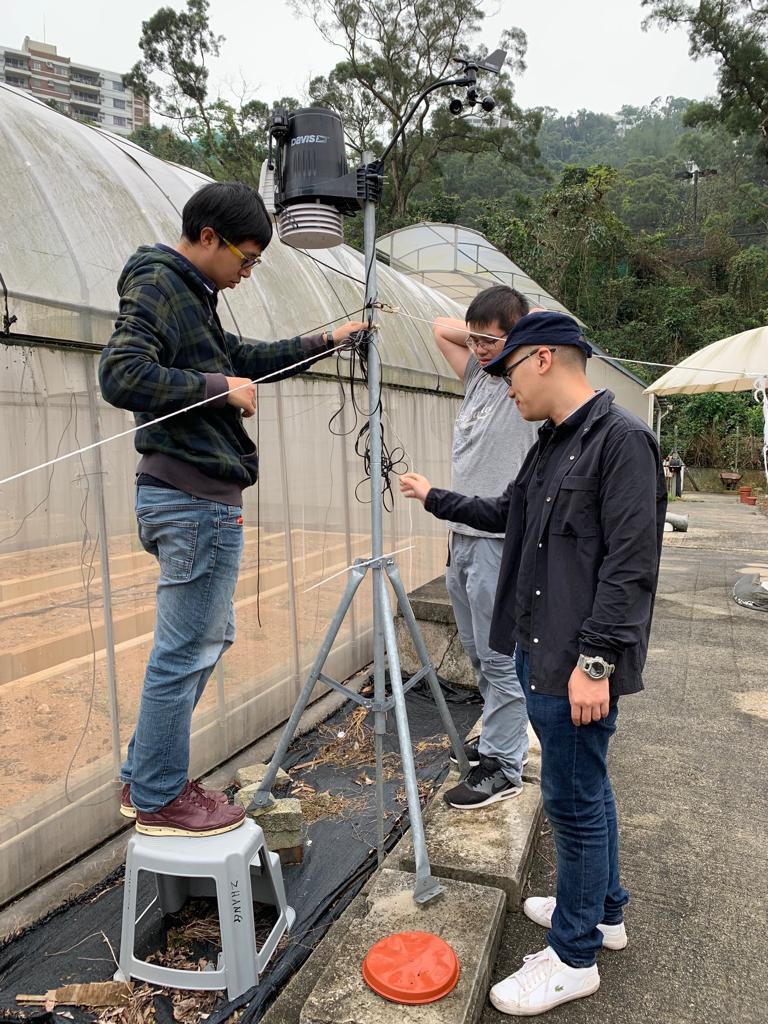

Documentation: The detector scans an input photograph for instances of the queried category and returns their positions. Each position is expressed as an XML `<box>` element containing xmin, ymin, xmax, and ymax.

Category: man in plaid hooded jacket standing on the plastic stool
<box><xmin>99</xmin><ymin>182</ymin><xmax>366</xmax><ymax>836</ymax></box>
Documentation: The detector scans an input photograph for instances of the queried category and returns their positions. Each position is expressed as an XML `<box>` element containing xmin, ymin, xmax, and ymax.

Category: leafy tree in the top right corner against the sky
<box><xmin>642</xmin><ymin>0</ymin><xmax>768</xmax><ymax>156</ymax></box>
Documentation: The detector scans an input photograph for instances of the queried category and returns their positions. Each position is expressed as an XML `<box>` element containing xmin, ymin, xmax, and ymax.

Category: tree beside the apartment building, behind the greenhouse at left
<box><xmin>124</xmin><ymin>0</ymin><xmax>297</xmax><ymax>184</ymax></box>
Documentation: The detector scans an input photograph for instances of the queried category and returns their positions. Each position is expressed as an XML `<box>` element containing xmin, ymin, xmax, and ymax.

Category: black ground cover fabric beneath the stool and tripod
<box><xmin>0</xmin><ymin>684</ymin><xmax>480</xmax><ymax>1024</ymax></box>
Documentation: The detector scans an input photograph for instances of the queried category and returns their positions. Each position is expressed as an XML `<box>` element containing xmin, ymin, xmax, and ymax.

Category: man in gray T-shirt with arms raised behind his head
<box><xmin>433</xmin><ymin>285</ymin><xmax>536</xmax><ymax>810</ymax></box>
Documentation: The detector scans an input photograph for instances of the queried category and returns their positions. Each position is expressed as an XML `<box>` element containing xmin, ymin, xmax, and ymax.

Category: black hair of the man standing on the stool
<box><xmin>181</xmin><ymin>181</ymin><xmax>272</xmax><ymax>250</ymax></box>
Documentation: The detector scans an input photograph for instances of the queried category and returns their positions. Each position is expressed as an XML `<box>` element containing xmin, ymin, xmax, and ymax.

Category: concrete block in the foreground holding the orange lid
<box><xmin>299</xmin><ymin>868</ymin><xmax>506</xmax><ymax>1024</ymax></box>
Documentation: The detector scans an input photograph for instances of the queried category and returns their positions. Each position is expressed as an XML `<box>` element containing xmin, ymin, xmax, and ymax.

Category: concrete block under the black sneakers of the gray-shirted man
<box><xmin>398</xmin><ymin>769</ymin><xmax>542</xmax><ymax>910</ymax></box>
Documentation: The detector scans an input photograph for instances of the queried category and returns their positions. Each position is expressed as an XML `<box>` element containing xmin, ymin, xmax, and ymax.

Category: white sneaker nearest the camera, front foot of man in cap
<box><xmin>490</xmin><ymin>946</ymin><xmax>600</xmax><ymax>1017</ymax></box>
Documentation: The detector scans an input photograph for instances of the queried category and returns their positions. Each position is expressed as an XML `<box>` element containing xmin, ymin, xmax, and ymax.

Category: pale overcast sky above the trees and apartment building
<box><xmin>0</xmin><ymin>0</ymin><xmax>715</xmax><ymax>114</ymax></box>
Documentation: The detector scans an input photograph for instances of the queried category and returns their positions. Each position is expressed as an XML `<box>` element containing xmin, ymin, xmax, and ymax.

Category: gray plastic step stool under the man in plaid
<box><xmin>115</xmin><ymin>818</ymin><xmax>296</xmax><ymax>999</ymax></box>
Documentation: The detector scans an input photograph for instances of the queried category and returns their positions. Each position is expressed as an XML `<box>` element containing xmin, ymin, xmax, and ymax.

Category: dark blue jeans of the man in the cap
<box><xmin>515</xmin><ymin>647</ymin><xmax>630</xmax><ymax>967</ymax></box>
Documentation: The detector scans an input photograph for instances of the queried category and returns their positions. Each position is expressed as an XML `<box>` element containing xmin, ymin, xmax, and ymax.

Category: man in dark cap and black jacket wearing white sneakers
<box><xmin>400</xmin><ymin>313</ymin><xmax>667</xmax><ymax>1016</ymax></box>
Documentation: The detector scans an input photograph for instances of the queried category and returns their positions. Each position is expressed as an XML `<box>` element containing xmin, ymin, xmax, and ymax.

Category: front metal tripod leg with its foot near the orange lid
<box><xmin>375</xmin><ymin>573</ymin><xmax>444</xmax><ymax>903</ymax></box>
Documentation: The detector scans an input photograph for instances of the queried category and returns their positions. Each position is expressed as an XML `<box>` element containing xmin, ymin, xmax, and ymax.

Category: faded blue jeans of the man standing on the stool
<box><xmin>120</xmin><ymin>486</ymin><xmax>243</xmax><ymax>812</ymax></box>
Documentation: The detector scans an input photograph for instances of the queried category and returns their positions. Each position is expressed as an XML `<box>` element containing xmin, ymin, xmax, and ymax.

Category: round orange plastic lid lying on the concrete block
<box><xmin>362</xmin><ymin>932</ymin><xmax>461</xmax><ymax>1005</ymax></box>
